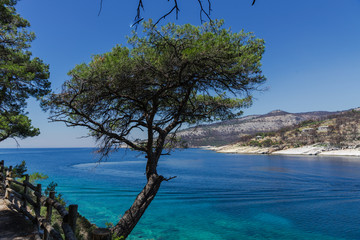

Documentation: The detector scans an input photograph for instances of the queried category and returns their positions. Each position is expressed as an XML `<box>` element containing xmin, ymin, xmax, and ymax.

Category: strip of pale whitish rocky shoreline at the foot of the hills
<box><xmin>202</xmin><ymin>144</ymin><xmax>360</xmax><ymax>157</ymax></box>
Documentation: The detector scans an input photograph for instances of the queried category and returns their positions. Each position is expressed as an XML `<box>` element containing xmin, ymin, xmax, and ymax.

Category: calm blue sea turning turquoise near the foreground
<box><xmin>0</xmin><ymin>148</ymin><xmax>360</xmax><ymax>240</ymax></box>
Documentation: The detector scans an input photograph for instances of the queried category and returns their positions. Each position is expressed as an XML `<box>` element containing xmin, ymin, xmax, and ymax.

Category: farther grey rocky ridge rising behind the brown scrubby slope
<box><xmin>178</xmin><ymin>110</ymin><xmax>341</xmax><ymax>147</ymax></box>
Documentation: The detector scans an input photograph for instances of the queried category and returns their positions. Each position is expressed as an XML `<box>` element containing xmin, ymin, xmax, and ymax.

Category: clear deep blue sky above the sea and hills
<box><xmin>0</xmin><ymin>0</ymin><xmax>360</xmax><ymax>148</ymax></box>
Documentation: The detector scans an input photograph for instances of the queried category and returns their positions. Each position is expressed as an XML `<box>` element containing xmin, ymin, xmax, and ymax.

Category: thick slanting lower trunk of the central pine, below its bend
<box><xmin>112</xmin><ymin>174</ymin><xmax>164</xmax><ymax>238</ymax></box>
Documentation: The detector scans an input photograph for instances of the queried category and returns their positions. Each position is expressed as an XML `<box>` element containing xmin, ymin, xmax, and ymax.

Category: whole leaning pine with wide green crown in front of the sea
<box><xmin>46</xmin><ymin>21</ymin><xmax>265</xmax><ymax>237</ymax></box>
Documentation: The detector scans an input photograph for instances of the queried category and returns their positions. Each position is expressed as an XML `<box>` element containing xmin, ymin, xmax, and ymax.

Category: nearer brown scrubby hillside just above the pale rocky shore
<box><xmin>236</xmin><ymin>108</ymin><xmax>360</xmax><ymax>151</ymax></box>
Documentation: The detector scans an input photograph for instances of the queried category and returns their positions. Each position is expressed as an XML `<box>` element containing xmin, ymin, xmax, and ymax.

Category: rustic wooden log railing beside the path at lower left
<box><xmin>0</xmin><ymin>160</ymin><xmax>78</xmax><ymax>240</ymax></box>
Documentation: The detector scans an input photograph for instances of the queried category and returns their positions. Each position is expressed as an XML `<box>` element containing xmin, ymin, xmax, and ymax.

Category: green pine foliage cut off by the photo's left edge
<box><xmin>0</xmin><ymin>0</ymin><xmax>50</xmax><ymax>141</ymax></box>
